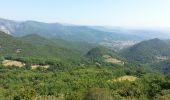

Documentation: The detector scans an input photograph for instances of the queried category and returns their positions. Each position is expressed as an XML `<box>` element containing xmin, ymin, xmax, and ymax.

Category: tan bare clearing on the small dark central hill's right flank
<box><xmin>103</xmin><ymin>55</ymin><xmax>124</xmax><ymax>64</ymax></box>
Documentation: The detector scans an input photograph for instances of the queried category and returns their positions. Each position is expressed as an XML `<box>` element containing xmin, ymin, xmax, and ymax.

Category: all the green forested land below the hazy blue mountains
<box><xmin>0</xmin><ymin>32</ymin><xmax>170</xmax><ymax>100</ymax></box>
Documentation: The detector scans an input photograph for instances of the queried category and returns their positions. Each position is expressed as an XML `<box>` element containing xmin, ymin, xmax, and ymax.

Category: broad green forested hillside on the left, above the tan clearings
<box><xmin>0</xmin><ymin>32</ymin><xmax>90</xmax><ymax>59</ymax></box>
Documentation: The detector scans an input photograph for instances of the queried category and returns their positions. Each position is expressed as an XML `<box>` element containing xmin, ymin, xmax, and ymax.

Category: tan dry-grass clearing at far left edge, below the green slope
<box><xmin>2</xmin><ymin>60</ymin><xmax>25</xmax><ymax>67</ymax></box>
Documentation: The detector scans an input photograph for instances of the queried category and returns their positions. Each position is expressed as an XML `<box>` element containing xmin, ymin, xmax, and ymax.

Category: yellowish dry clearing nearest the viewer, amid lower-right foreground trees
<box><xmin>107</xmin><ymin>75</ymin><xmax>138</xmax><ymax>82</ymax></box>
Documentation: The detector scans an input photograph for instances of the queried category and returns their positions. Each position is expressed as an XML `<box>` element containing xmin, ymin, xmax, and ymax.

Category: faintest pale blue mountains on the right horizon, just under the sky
<box><xmin>92</xmin><ymin>26</ymin><xmax>170</xmax><ymax>40</ymax></box>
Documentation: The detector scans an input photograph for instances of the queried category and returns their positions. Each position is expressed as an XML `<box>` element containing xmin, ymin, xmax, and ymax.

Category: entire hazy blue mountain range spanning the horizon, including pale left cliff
<box><xmin>0</xmin><ymin>18</ymin><xmax>170</xmax><ymax>43</ymax></box>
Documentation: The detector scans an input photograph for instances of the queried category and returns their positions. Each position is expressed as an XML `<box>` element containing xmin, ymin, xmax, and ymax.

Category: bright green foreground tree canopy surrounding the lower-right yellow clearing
<box><xmin>0</xmin><ymin>58</ymin><xmax>167</xmax><ymax>100</ymax></box>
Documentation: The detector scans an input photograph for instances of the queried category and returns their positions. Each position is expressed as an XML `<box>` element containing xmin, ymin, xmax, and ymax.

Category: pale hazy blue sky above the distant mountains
<box><xmin>0</xmin><ymin>0</ymin><xmax>170</xmax><ymax>27</ymax></box>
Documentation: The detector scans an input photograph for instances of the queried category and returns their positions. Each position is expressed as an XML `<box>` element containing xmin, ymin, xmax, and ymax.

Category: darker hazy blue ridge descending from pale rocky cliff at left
<box><xmin>0</xmin><ymin>19</ymin><xmax>145</xmax><ymax>42</ymax></box>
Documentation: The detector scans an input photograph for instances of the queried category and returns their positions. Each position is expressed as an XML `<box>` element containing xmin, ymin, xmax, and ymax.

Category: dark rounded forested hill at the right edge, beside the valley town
<box><xmin>121</xmin><ymin>38</ymin><xmax>170</xmax><ymax>63</ymax></box>
